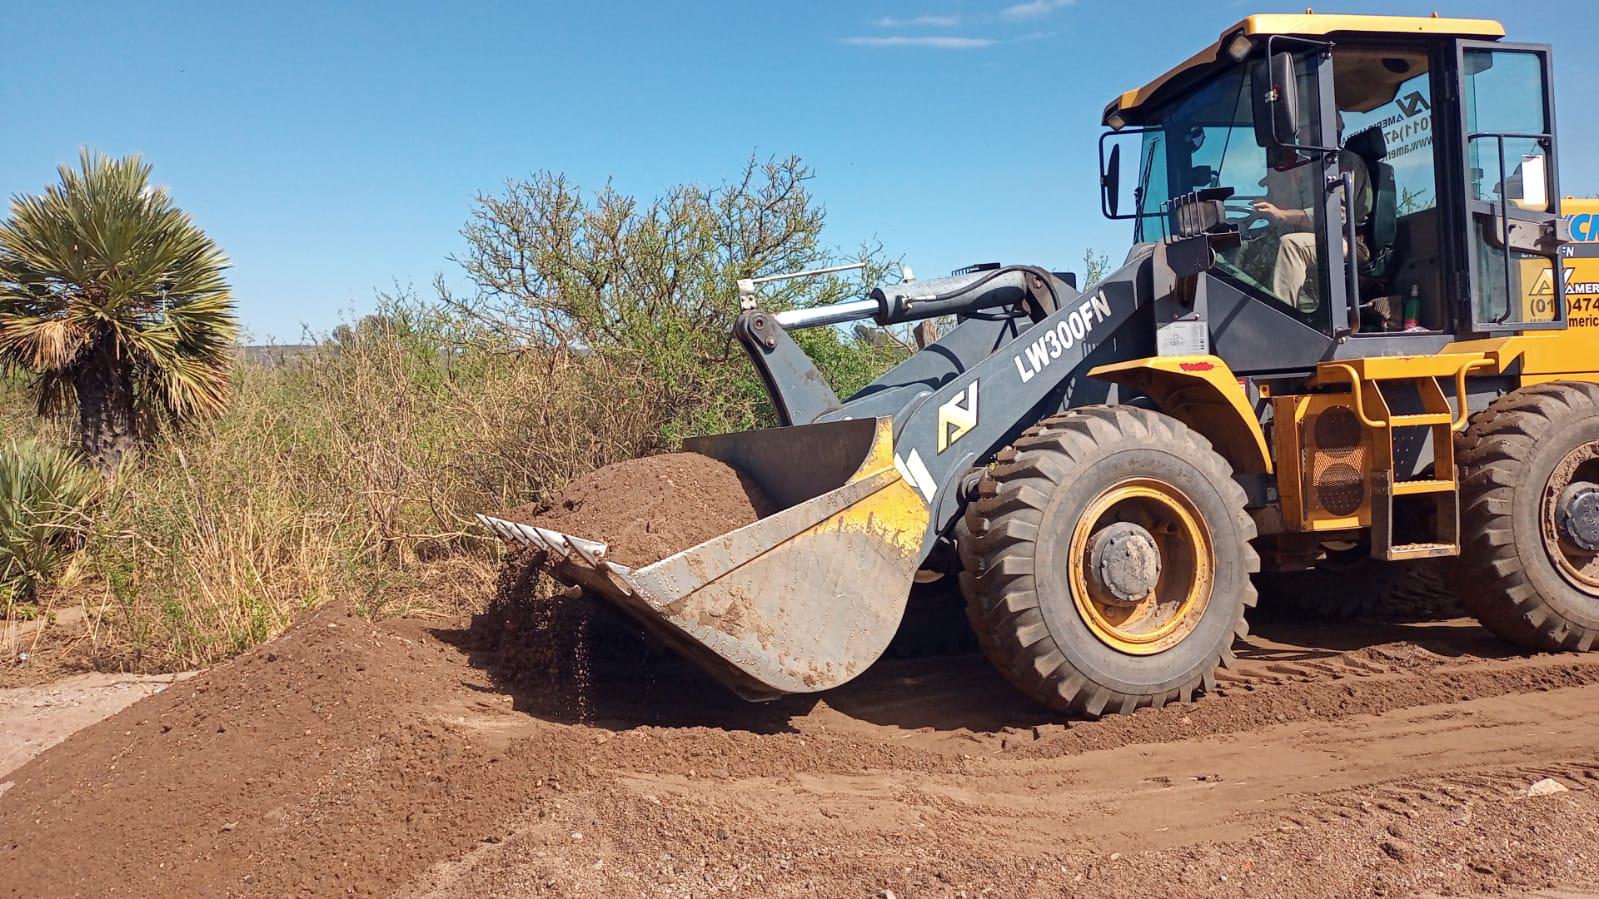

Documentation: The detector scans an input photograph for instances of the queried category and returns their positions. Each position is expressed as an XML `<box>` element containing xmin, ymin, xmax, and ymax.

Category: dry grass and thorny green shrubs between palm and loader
<box><xmin>9</xmin><ymin>153</ymin><xmax>905</xmax><ymax>669</ymax></box>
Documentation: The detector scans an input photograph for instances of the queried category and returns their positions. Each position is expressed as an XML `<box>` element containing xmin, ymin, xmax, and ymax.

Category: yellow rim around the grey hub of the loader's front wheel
<box><xmin>1067</xmin><ymin>478</ymin><xmax>1215</xmax><ymax>656</ymax></box>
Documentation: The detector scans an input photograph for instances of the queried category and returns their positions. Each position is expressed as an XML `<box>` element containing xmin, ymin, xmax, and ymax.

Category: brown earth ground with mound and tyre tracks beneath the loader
<box><xmin>0</xmin><ymin>591</ymin><xmax>1599</xmax><ymax>897</ymax></box>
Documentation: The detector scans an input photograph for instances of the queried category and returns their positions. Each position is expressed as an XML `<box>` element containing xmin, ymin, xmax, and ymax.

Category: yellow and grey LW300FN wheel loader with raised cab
<box><xmin>483</xmin><ymin>13</ymin><xmax>1599</xmax><ymax>715</ymax></box>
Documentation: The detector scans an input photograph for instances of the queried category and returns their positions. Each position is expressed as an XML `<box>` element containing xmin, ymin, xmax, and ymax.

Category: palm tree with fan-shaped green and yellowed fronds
<box><xmin>0</xmin><ymin>150</ymin><xmax>238</xmax><ymax>473</ymax></box>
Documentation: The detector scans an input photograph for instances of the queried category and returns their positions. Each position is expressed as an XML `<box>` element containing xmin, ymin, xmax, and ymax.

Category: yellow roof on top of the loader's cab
<box><xmin>1105</xmin><ymin>10</ymin><xmax>1505</xmax><ymax>125</ymax></box>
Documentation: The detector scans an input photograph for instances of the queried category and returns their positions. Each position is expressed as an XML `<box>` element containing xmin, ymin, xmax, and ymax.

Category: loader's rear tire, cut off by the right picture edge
<box><xmin>1453</xmin><ymin>381</ymin><xmax>1599</xmax><ymax>651</ymax></box>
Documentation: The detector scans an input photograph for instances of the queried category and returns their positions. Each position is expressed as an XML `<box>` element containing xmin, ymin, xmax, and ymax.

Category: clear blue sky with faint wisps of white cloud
<box><xmin>0</xmin><ymin>0</ymin><xmax>1599</xmax><ymax>341</ymax></box>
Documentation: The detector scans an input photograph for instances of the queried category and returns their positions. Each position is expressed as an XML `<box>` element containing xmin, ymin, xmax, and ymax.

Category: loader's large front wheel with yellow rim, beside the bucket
<box><xmin>961</xmin><ymin>406</ymin><xmax>1260</xmax><ymax>717</ymax></box>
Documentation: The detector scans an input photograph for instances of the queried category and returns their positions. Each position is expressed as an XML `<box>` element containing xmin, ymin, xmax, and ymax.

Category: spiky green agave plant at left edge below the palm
<box><xmin>0</xmin><ymin>440</ymin><xmax>101</xmax><ymax>611</ymax></box>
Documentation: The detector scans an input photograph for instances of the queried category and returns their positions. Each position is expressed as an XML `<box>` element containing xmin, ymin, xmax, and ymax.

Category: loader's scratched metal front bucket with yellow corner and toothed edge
<box><xmin>480</xmin><ymin>418</ymin><xmax>927</xmax><ymax>699</ymax></box>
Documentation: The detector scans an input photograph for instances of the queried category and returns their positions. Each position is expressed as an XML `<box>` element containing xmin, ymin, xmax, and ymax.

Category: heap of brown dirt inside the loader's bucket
<box><xmin>508</xmin><ymin>453</ymin><xmax>776</xmax><ymax>568</ymax></box>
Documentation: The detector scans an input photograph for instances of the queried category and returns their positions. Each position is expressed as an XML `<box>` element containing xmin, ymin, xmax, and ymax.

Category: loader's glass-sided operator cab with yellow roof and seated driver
<box><xmin>1102</xmin><ymin>14</ymin><xmax>1564</xmax><ymax>360</ymax></box>
